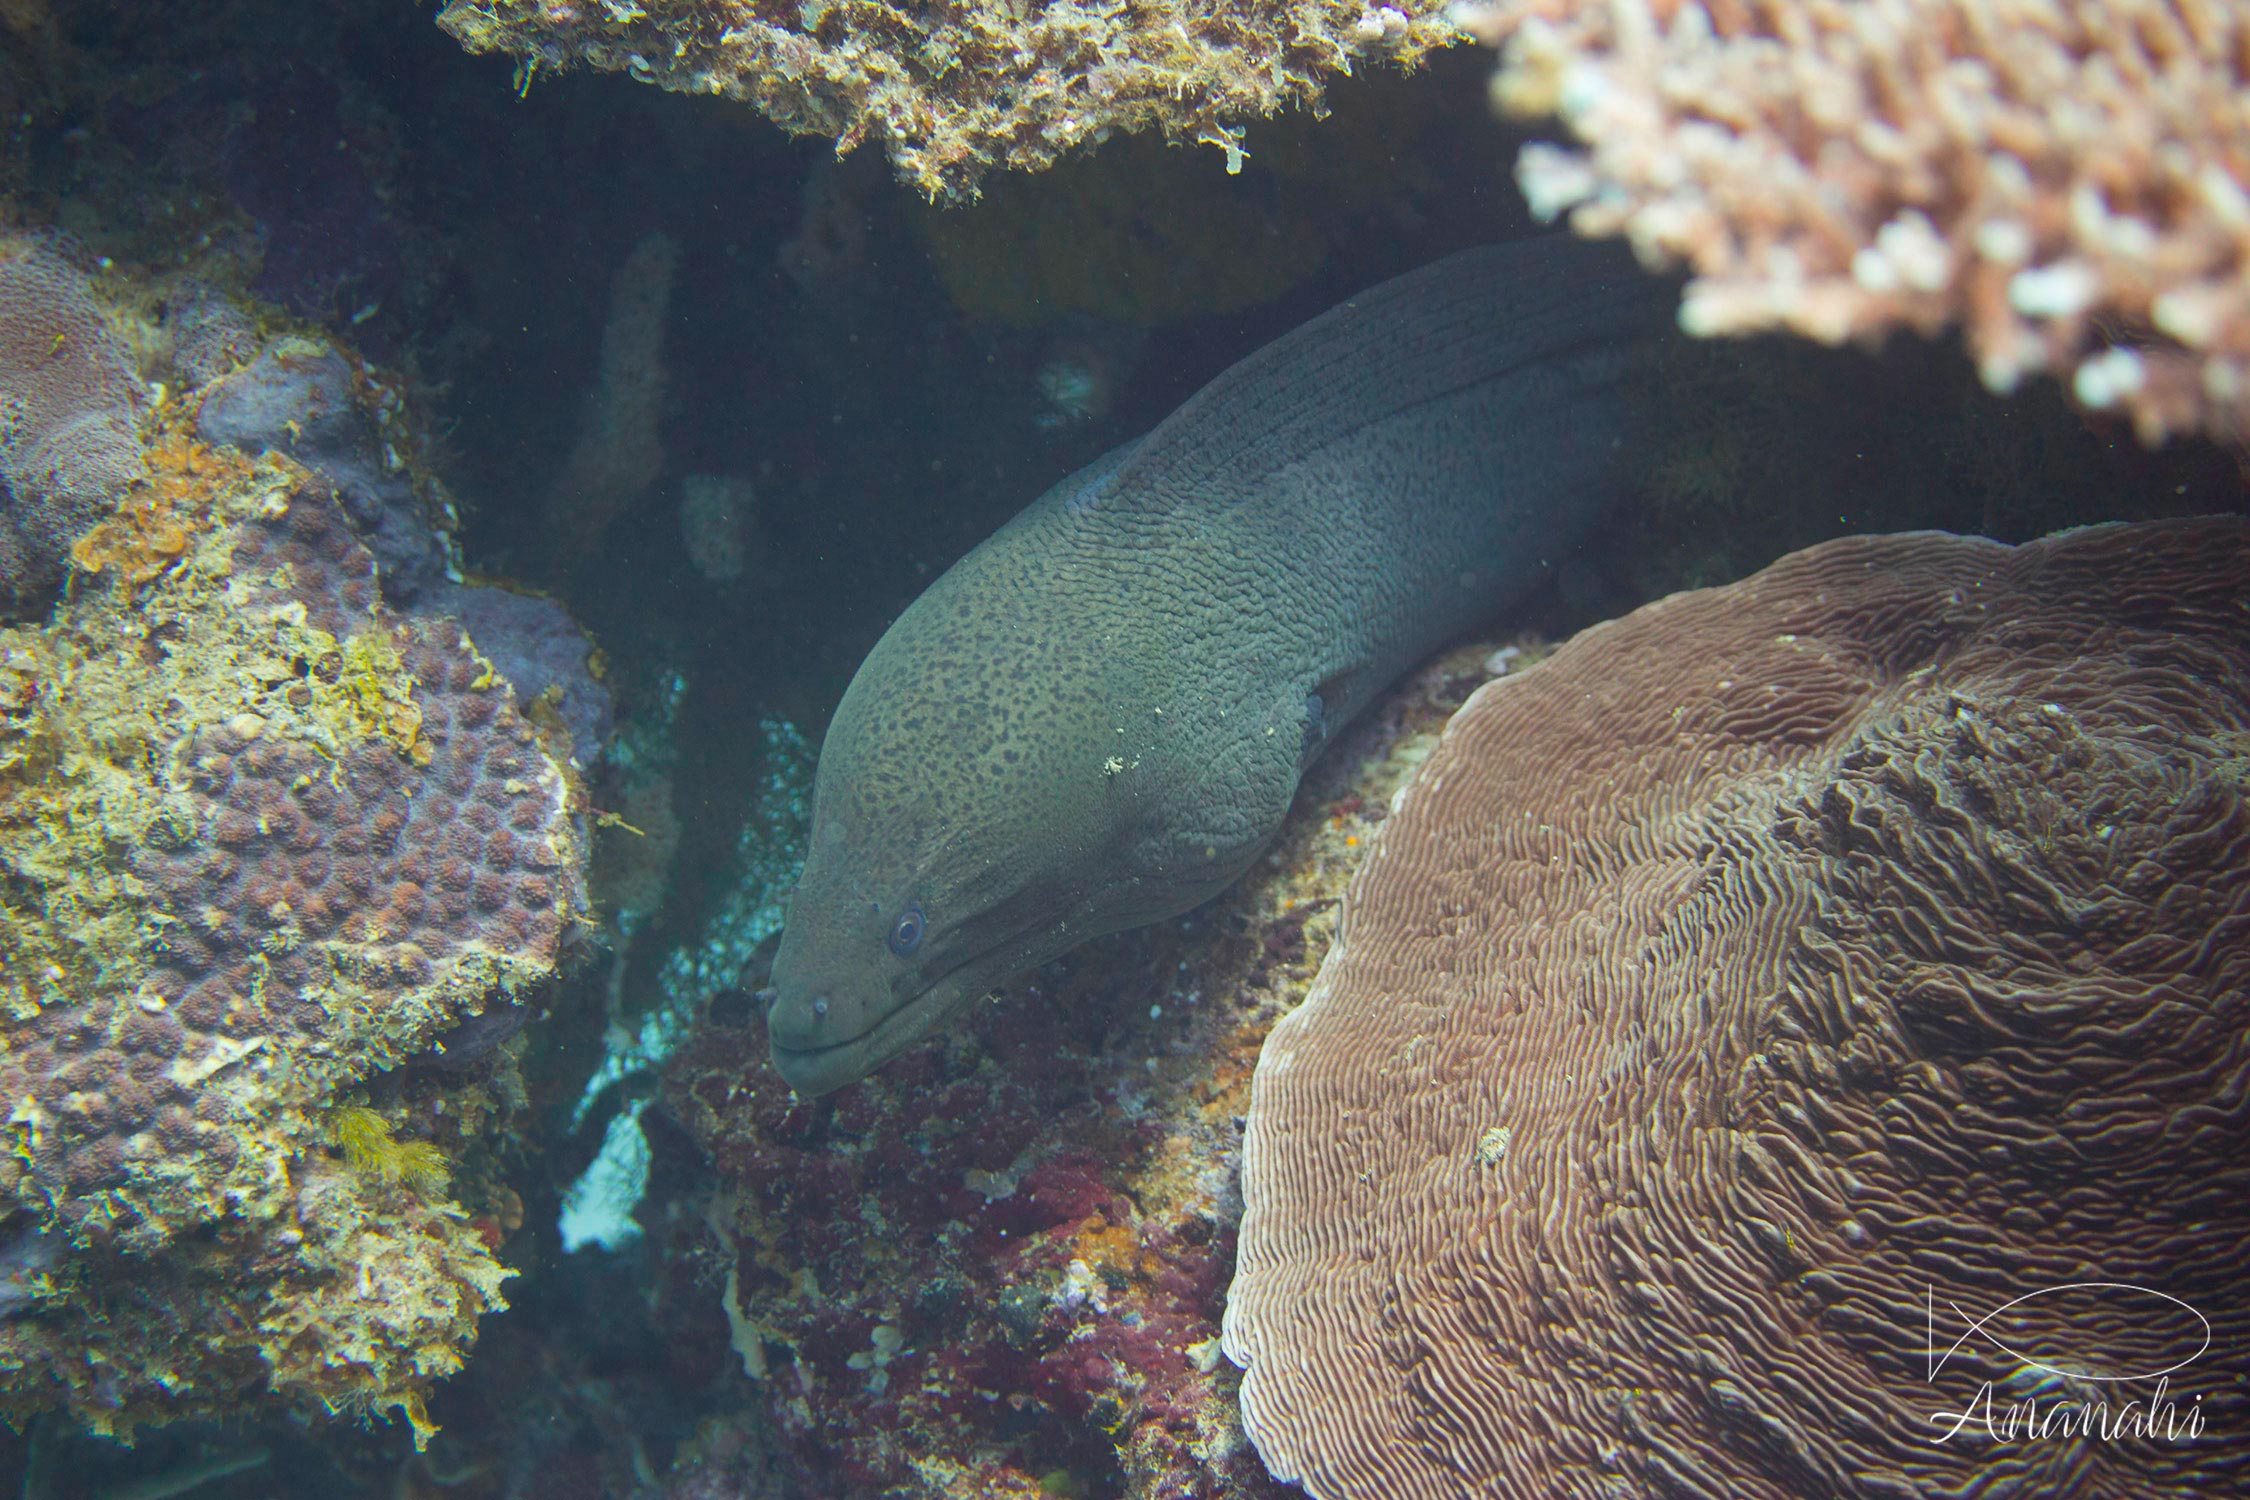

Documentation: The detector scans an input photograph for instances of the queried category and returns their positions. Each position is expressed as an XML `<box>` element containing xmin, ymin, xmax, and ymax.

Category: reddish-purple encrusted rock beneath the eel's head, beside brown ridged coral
<box><xmin>646</xmin><ymin>645</ymin><xmax>1490</xmax><ymax>1500</ymax></box>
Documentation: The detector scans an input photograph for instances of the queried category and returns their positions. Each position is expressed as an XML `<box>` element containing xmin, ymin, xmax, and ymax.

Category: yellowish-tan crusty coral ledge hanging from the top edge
<box><xmin>439</xmin><ymin>0</ymin><xmax>1460</xmax><ymax>198</ymax></box>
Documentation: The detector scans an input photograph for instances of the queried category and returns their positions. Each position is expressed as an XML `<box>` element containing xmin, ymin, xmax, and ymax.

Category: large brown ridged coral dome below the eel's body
<box><xmin>1226</xmin><ymin>519</ymin><xmax>2250</xmax><ymax>1500</ymax></box>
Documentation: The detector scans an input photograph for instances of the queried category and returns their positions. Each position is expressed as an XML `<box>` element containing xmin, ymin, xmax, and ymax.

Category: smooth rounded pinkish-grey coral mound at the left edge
<box><xmin>0</xmin><ymin>234</ymin><xmax>142</xmax><ymax>621</ymax></box>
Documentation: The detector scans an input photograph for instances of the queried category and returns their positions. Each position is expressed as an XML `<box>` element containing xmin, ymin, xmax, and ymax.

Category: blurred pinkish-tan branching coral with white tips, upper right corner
<box><xmin>1465</xmin><ymin>0</ymin><xmax>2250</xmax><ymax>443</ymax></box>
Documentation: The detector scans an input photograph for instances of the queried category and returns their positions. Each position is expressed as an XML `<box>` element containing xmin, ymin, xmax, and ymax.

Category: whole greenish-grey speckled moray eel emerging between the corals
<box><xmin>770</xmin><ymin>238</ymin><xmax>1670</xmax><ymax>1095</ymax></box>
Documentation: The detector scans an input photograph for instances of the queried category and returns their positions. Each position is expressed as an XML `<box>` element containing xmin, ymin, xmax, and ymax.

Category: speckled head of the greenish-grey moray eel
<box><xmin>767</xmin><ymin>546</ymin><xmax>1134</xmax><ymax>1095</ymax></box>
